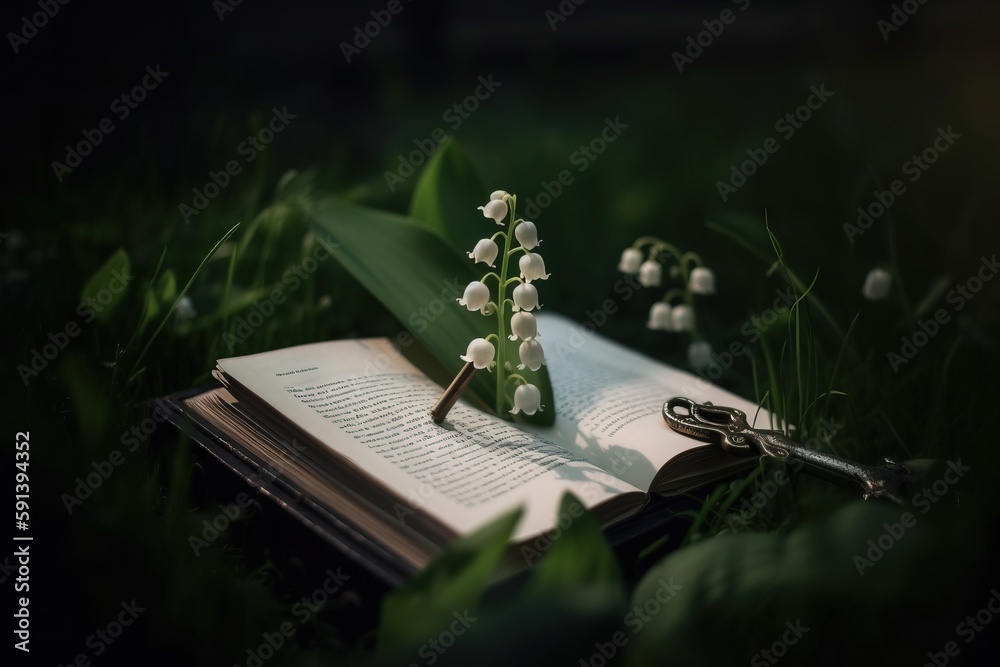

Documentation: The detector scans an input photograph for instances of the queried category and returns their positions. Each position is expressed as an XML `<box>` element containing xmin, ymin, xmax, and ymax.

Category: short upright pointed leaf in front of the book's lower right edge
<box><xmin>521</xmin><ymin>492</ymin><xmax>622</xmax><ymax>594</ymax></box>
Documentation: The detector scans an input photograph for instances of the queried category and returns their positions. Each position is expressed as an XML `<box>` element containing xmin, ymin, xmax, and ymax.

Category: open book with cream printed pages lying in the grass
<box><xmin>184</xmin><ymin>314</ymin><xmax>756</xmax><ymax>568</ymax></box>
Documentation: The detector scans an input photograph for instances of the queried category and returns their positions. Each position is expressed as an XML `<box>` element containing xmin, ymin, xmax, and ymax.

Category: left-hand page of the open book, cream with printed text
<box><xmin>219</xmin><ymin>339</ymin><xmax>639</xmax><ymax>539</ymax></box>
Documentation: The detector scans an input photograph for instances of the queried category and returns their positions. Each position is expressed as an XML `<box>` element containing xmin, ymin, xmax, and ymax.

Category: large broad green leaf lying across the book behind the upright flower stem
<box><xmin>311</xmin><ymin>198</ymin><xmax>555</xmax><ymax>426</ymax></box>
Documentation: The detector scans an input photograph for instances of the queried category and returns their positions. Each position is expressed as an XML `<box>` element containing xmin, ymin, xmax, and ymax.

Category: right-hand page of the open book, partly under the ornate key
<box><xmin>532</xmin><ymin>313</ymin><xmax>766</xmax><ymax>491</ymax></box>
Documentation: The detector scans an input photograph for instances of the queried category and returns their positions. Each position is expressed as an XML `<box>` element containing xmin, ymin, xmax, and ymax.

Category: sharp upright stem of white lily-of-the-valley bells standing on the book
<box><xmin>458</xmin><ymin>190</ymin><xmax>549</xmax><ymax>415</ymax></box>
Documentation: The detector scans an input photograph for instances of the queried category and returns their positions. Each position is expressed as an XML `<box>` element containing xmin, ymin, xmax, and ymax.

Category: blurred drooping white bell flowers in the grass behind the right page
<box><xmin>618</xmin><ymin>243</ymin><xmax>715</xmax><ymax>368</ymax></box>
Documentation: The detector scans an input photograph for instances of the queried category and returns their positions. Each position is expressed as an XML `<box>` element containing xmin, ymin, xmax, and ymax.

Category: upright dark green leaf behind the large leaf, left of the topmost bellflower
<box><xmin>410</xmin><ymin>138</ymin><xmax>488</xmax><ymax>252</ymax></box>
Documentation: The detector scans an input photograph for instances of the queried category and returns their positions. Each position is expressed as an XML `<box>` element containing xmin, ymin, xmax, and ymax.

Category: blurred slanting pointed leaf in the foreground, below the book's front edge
<box><xmin>378</xmin><ymin>510</ymin><xmax>521</xmax><ymax>655</ymax></box>
